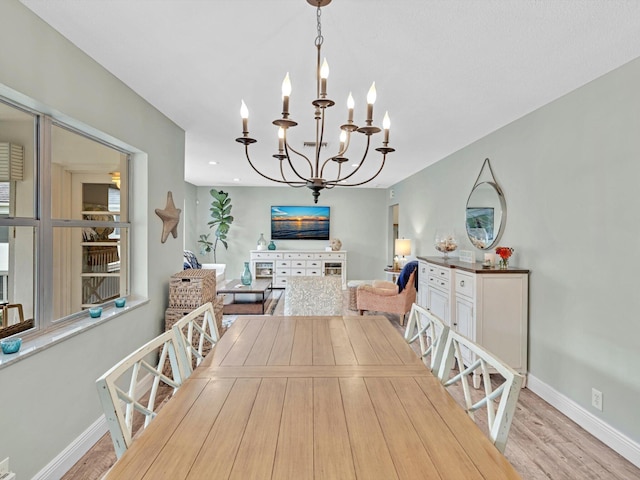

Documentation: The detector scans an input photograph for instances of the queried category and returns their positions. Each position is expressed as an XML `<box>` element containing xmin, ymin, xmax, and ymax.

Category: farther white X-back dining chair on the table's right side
<box><xmin>404</xmin><ymin>303</ymin><xmax>449</xmax><ymax>374</ymax></box>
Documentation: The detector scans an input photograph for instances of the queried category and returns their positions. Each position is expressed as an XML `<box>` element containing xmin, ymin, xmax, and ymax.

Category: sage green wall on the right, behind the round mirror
<box><xmin>393</xmin><ymin>59</ymin><xmax>640</xmax><ymax>442</ymax></box>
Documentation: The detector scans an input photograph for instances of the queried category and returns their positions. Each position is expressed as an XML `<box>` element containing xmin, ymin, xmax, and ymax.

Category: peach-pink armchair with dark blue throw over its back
<box><xmin>356</xmin><ymin>270</ymin><xmax>416</xmax><ymax>325</ymax></box>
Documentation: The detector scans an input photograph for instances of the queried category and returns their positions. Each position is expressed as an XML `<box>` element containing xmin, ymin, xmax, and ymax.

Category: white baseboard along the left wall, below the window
<box><xmin>31</xmin><ymin>375</ymin><xmax>153</xmax><ymax>480</ymax></box>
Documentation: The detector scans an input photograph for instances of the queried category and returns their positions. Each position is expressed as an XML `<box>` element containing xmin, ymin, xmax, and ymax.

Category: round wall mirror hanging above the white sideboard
<box><xmin>466</xmin><ymin>182</ymin><xmax>507</xmax><ymax>250</ymax></box>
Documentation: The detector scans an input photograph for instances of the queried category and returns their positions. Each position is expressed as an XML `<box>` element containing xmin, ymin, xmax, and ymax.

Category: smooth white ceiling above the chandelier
<box><xmin>21</xmin><ymin>0</ymin><xmax>640</xmax><ymax>191</ymax></box>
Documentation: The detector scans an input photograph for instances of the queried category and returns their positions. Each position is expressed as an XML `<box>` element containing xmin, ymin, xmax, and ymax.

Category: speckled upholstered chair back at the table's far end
<box><xmin>284</xmin><ymin>276</ymin><xmax>342</xmax><ymax>316</ymax></box>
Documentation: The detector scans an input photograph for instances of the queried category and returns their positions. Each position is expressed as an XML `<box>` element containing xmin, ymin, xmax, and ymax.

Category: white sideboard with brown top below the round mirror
<box><xmin>418</xmin><ymin>257</ymin><xmax>529</xmax><ymax>381</ymax></box>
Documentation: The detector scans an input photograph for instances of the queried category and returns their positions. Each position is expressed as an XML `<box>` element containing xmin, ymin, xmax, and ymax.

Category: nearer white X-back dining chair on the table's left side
<box><xmin>96</xmin><ymin>330</ymin><xmax>186</xmax><ymax>458</ymax></box>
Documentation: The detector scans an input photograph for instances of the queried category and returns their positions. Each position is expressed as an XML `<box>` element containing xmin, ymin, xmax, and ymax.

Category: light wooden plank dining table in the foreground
<box><xmin>106</xmin><ymin>316</ymin><xmax>520</xmax><ymax>480</ymax></box>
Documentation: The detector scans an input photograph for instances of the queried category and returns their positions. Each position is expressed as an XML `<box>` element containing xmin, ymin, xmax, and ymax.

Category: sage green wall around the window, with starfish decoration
<box><xmin>0</xmin><ymin>0</ymin><xmax>184</xmax><ymax>479</ymax></box>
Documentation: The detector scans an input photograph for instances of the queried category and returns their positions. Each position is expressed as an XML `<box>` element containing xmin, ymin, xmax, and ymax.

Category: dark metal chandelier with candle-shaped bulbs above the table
<box><xmin>236</xmin><ymin>0</ymin><xmax>395</xmax><ymax>203</ymax></box>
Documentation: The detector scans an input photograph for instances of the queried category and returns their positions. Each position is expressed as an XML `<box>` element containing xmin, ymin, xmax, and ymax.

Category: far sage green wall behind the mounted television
<box><xmin>189</xmin><ymin>187</ymin><xmax>389</xmax><ymax>279</ymax></box>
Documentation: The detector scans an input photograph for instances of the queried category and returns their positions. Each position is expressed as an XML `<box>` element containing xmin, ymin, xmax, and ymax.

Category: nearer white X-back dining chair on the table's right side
<box><xmin>438</xmin><ymin>330</ymin><xmax>524</xmax><ymax>453</ymax></box>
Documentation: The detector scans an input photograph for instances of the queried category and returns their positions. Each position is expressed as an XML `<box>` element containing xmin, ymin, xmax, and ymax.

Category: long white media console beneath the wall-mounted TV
<box><xmin>250</xmin><ymin>250</ymin><xmax>347</xmax><ymax>289</ymax></box>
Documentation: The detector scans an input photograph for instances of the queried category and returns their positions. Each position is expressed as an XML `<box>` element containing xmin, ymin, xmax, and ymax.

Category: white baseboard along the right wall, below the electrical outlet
<box><xmin>527</xmin><ymin>374</ymin><xmax>640</xmax><ymax>467</ymax></box>
